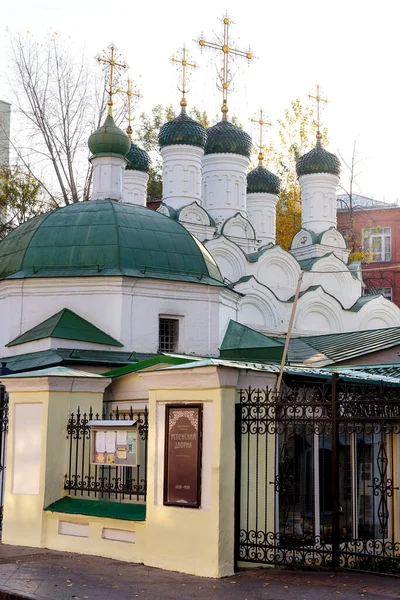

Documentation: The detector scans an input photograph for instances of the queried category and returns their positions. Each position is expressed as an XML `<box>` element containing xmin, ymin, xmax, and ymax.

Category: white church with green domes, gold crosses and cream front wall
<box><xmin>0</xmin><ymin>18</ymin><xmax>400</xmax><ymax>577</ymax></box>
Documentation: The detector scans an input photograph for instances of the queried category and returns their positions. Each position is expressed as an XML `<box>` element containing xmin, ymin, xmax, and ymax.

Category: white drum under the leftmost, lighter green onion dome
<box><xmin>90</xmin><ymin>156</ymin><xmax>128</xmax><ymax>202</ymax></box>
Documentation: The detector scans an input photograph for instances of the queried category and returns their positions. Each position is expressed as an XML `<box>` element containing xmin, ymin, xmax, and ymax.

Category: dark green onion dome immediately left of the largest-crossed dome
<box><xmin>158</xmin><ymin>108</ymin><xmax>207</xmax><ymax>148</ymax></box>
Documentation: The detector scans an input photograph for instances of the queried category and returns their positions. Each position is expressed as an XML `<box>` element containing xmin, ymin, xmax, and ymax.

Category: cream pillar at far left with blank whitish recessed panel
<box><xmin>2</xmin><ymin>377</ymin><xmax>110</xmax><ymax>547</ymax></box>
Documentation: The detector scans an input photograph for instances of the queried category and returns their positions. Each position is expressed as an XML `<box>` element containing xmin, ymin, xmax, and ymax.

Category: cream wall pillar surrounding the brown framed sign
<box><xmin>145</xmin><ymin>384</ymin><xmax>236</xmax><ymax>577</ymax></box>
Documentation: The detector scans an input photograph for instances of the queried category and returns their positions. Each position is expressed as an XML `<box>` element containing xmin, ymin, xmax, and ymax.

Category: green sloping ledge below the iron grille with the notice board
<box><xmin>44</xmin><ymin>496</ymin><xmax>146</xmax><ymax>521</ymax></box>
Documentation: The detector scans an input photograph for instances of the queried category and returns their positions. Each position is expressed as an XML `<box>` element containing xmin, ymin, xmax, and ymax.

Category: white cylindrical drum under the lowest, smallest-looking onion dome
<box><xmin>247</xmin><ymin>194</ymin><xmax>278</xmax><ymax>246</ymax></box>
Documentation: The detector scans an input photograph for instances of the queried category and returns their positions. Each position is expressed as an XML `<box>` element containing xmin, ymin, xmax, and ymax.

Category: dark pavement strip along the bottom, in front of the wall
<box><xmin>0</xmin><ymin>544</ymin><xmax>400</xmax><ymax>600</ymax></box>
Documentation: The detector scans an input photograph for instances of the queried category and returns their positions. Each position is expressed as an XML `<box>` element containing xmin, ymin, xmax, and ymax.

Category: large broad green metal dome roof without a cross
<box><xmin>0</xmin><ymin>200</ymin><xmax>222</xmax><ymax>285</ymax></box>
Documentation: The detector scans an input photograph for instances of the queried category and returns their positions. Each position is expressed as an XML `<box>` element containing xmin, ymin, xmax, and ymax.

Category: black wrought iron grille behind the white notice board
<box><xmin>64</xmin><ymin>407</ymin><xmax>148</xmax><ymax>502</ymax></box>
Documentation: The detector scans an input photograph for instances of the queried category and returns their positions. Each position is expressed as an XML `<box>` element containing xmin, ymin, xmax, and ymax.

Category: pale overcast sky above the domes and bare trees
<box><xmin>0</xmin><ymin>0</ymin><xmax>400</xmax><ymax>202</ymax></box>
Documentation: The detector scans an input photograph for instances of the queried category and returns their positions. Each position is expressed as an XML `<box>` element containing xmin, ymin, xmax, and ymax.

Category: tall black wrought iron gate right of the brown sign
<box><xmin>235</xmin><ymin>375</ymin><xmax>400</xmax><ymax>575</ymax></box>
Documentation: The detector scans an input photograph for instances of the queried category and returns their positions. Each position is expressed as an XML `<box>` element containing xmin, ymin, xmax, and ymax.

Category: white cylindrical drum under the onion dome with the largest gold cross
<box><xmin>202</xmin><ymin>154</ymin><xmax>249</xmax><ymax>223</ymax></box>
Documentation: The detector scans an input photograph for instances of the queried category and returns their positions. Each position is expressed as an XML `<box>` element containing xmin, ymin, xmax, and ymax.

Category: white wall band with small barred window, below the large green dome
<box><xmin>0</xmin><ymin>277</ymin><xmax>238</xmax><ymax>356</ymax></box>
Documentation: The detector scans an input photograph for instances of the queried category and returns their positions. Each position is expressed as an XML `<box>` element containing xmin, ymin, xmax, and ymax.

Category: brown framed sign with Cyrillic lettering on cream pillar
<box><xmin>164</xmin><ymin>404</ymin><xmax>203</xmax><ymax>508</ymax></box>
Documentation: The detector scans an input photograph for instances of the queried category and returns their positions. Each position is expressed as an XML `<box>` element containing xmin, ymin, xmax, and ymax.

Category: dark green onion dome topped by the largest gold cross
<box><xmin>204</xmin><ymin>120</ymin><xmax>252</xmax><ymax>158</ymax></box>
